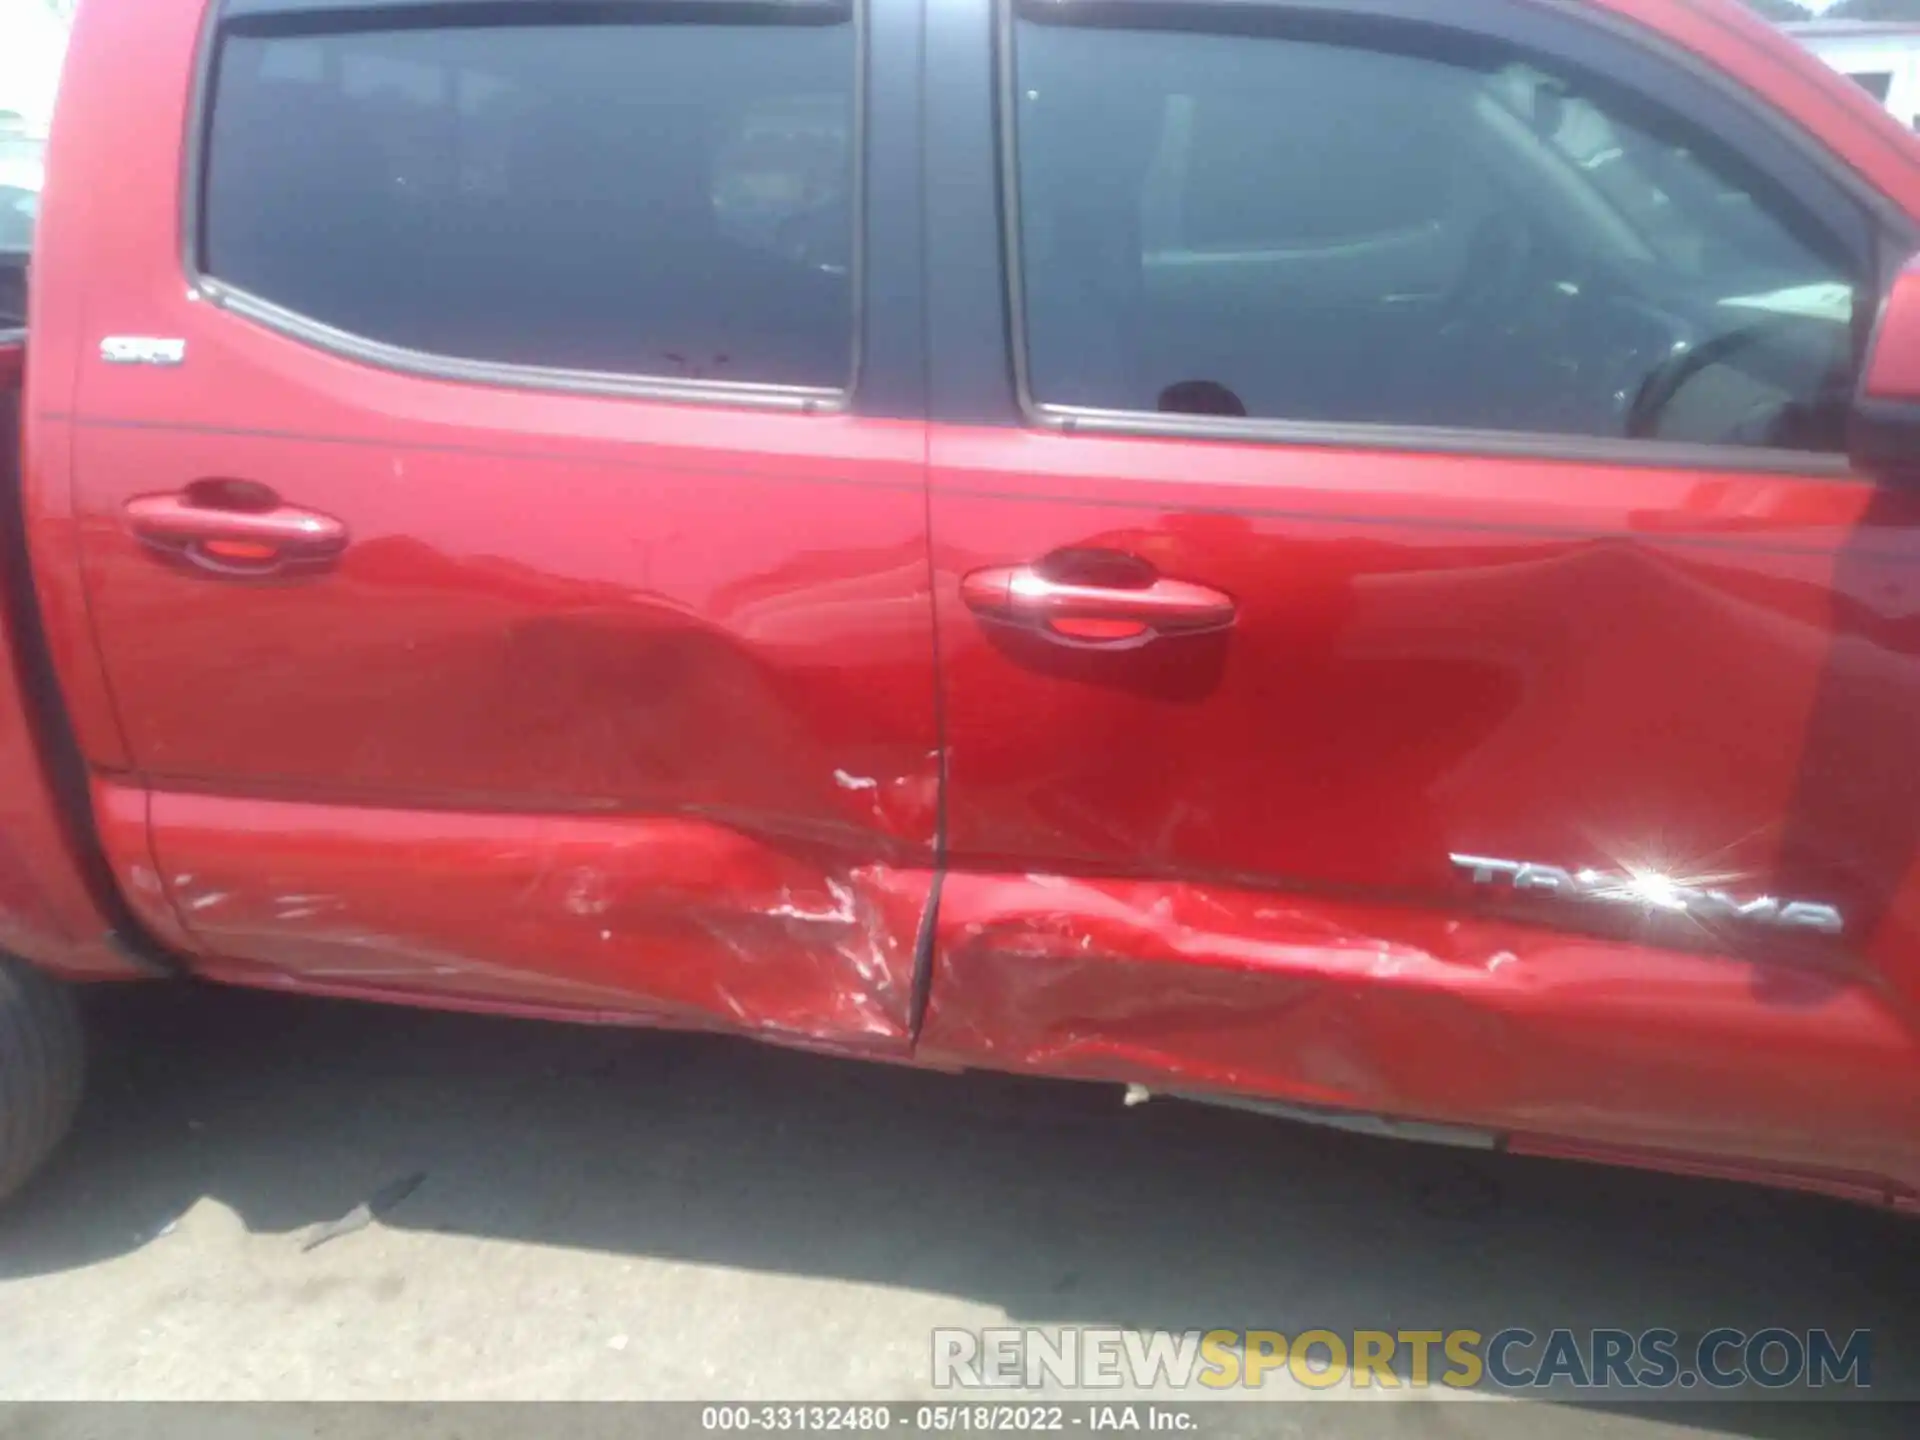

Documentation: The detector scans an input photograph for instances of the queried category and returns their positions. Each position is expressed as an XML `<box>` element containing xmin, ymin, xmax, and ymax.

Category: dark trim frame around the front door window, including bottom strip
<box><xmin>991</xmin><ymin>0</ymin><xmax>1920</xmax><ymax>480</ymax></box>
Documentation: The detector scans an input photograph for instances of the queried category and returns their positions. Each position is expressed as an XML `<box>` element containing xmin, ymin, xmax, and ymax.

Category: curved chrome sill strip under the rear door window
<box><xmin>188</xmin><ymin>276</ymin><xmax>851</xmax><ymax>415</ymax></box>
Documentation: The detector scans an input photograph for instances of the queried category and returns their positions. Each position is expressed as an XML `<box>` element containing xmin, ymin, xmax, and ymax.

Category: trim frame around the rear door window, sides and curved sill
<box><xmin>179</xmin><ymin>0</ymin><xmax>876</xmax><ymax>415</ymax></box>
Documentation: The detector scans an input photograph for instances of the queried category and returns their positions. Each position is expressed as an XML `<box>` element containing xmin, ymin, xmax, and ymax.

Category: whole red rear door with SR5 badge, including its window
<box><xmin>40</xmin><ymin>0</ymin><xmax>937</xmax><ymax>1048</ymax></box>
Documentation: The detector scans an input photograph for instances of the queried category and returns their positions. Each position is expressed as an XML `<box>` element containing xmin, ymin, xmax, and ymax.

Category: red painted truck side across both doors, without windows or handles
<box><xmin>11</xmin><ymin>0</ymin><xmax>1920</xmax><ymax>1198</ymax></box>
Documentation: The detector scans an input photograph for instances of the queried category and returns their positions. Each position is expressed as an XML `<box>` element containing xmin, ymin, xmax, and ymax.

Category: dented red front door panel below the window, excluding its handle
<box><xmin>924</xmin><ymin>426</ymin><xmax>1920</xmax><ymax>1183</ymax></box>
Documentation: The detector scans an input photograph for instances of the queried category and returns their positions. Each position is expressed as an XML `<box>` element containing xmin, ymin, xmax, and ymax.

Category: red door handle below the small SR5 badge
<box><xmin>127</xmin><ymin>480</ymin><xmax>348</xmax><ymax>578</ymax></box>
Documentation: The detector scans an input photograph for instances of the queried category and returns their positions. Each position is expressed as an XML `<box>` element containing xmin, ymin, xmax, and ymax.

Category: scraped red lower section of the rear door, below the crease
<box><xmin>154</xmin><ymin>791</ymin><xmax>931</xmax><ymax>1052</ymax></box>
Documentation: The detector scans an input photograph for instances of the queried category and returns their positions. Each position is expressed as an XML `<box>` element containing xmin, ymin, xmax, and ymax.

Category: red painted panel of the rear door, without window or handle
<box><xmin>35</xmin><ymin>4</ymin><xmax>939</xmax><ymax>1048</ymax></box>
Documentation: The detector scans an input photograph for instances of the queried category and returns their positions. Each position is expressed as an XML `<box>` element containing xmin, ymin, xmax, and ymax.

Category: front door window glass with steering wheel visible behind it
<box><xmin>1014</xmin><ymin>21</ymin><xmax>1859</xmax><ymax>449</ymax></box>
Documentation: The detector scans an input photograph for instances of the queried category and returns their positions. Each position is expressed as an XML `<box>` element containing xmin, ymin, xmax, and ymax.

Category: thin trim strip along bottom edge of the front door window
<box><xmin>1023</xmin><ymin>397</ymin><xmax>1862</xmax><ymax>480</ymax></box>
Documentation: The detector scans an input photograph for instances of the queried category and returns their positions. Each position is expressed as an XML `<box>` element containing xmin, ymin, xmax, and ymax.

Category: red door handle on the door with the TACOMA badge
<box><xmin>960</xmin><ymin>564</ymin><xmax>1235</xmax><ymax>645</ymax></box>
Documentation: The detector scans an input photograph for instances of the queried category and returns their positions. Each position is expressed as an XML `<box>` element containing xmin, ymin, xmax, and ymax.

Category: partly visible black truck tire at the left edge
<box><xmin>0</xmin><ymin>956</ymin><xmax>86</xmax><ymax>1200</ymax></box>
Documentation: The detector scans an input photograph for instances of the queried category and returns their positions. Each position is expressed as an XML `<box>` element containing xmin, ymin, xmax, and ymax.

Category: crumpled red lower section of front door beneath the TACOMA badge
<box><xmin>922</xmin><ymin>874</ymin><xmax>1920</xmax><ymax>1190</ymax></box>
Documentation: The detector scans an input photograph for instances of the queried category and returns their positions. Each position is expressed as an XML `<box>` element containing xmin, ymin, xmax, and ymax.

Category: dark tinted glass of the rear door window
<box><xmin>202</xmin><ymin>8</ymin><xmax>854</xmax><ymax>388</ymax></box>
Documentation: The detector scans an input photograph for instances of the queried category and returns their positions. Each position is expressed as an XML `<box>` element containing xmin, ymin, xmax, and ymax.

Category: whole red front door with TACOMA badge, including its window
<box><xmin>925</xmin><ymin>0</ymin><xmax>1920</xmax><ymax>1173</ymax></box>
